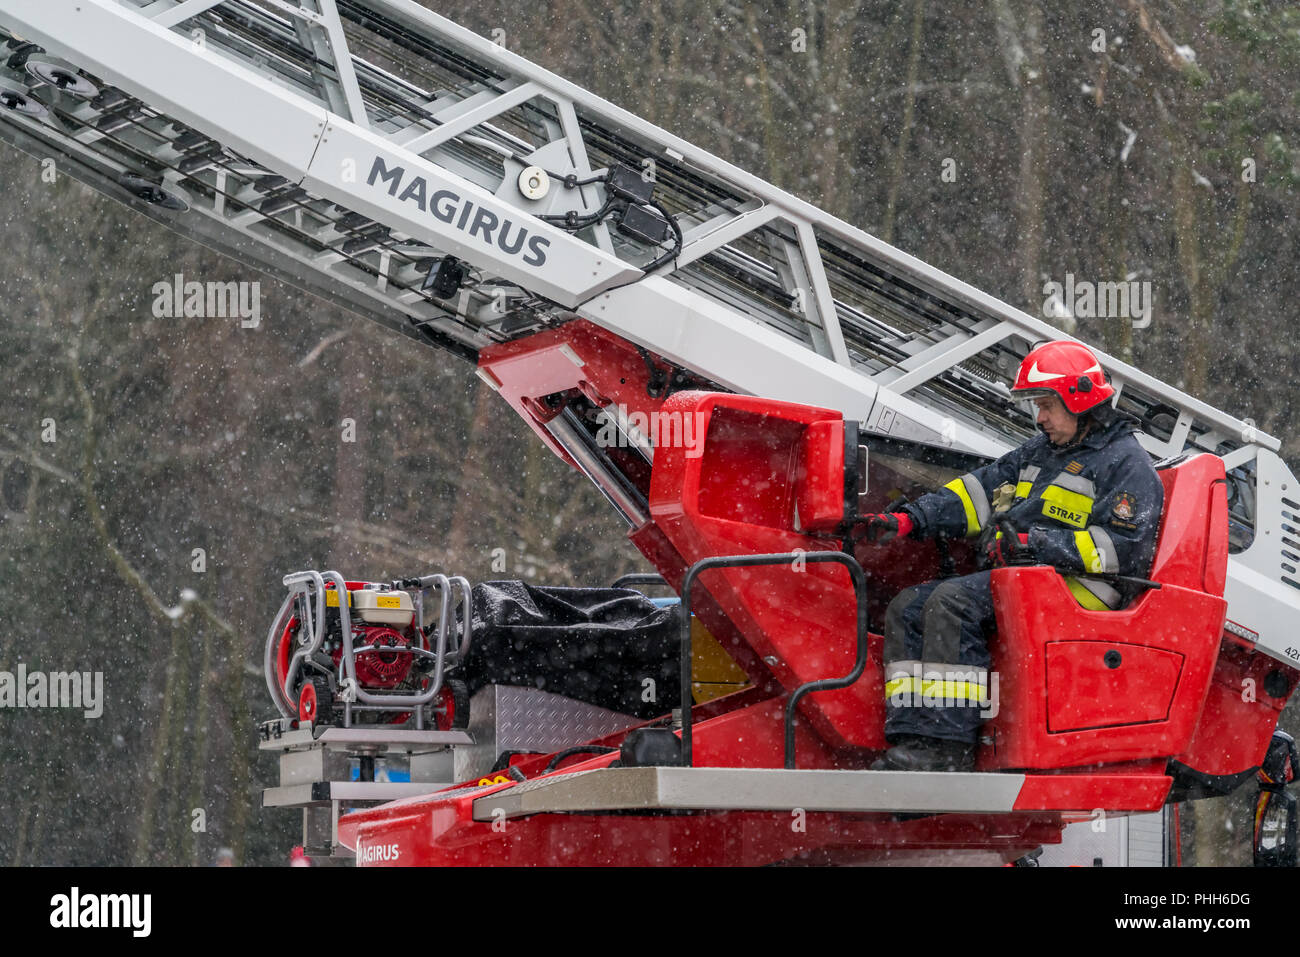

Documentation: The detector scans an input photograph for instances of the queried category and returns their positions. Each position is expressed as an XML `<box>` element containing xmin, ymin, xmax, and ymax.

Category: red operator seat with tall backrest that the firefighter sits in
<box><xmin>979</xmin><ymin>454</ymin><xmax>1227</xmax><ymax>770</ymax></box>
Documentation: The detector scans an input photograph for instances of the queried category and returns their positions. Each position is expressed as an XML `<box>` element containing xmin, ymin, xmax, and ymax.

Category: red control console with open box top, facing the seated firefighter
<box><xmin>650</xmin><ymin>391</ymin><xmax>885</xmax><ymax>748</ymax></box>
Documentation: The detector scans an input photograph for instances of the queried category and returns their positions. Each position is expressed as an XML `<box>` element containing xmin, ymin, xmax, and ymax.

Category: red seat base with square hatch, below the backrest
<box><xmin>979</xmin><ymin>567</ymin><xmax>1227</xmax><ymax>770</ymax></box>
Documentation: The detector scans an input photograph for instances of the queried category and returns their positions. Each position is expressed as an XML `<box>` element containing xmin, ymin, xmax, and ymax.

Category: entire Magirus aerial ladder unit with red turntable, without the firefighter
<box><xmin>0</xmin><ymin>0</ymin><xmax>1300</xmax><ymax>863</ymax></box>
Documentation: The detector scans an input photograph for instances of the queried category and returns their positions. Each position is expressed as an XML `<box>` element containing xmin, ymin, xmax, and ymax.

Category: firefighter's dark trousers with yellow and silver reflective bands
<box><xmin>884</xmin><ymin>571</ymin><xmax>995</xmax><ymax>744</ymax></box>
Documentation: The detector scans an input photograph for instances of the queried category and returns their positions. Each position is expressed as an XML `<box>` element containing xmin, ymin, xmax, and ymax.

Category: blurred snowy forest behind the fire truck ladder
<box><xmin>0</xmin><ymin>0</ymin><xmax>1300</xmax><ymax>865</ymax></box>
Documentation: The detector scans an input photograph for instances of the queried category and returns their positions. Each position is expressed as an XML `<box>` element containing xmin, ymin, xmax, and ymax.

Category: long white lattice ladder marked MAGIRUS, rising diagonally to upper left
<box><xmin>0</xmin><ymin>0</ymin><xmax>1300</xmax><ymax>659</ymax></box>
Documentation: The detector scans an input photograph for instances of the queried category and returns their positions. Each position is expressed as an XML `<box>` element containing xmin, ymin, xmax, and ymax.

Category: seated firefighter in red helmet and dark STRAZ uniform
<box><xmin>862</xmin><ymin>342</ymin><xmax>1165</xmax><ymax>771</ymax></box>
